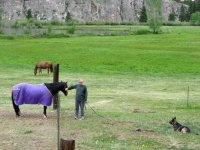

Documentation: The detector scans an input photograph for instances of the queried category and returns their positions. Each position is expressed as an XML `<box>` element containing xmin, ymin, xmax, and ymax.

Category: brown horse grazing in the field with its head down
<box><xmin>34</xmin><ymin>61</ymin><xmax>53</xmax><ymax>75</ymax></box>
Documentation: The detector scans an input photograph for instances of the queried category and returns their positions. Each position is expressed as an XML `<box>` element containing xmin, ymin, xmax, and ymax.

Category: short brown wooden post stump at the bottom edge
<box><xmin>60</xmin><ymin>138</ymin><xmax>75</xmax><ymax>150</ymax></box>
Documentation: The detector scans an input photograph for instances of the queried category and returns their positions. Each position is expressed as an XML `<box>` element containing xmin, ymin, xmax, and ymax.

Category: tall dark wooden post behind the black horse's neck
<box><xmin>53</xmin><ymin>64</ymin><xmax>59</xmax><ymax>110</ymax></box>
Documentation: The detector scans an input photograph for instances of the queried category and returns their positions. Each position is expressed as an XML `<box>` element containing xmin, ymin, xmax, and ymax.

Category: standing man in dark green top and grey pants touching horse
<box><xmin>65</xmin><ymin>79</ymin><xmax>88</xmax><ymax>119</ymax></box>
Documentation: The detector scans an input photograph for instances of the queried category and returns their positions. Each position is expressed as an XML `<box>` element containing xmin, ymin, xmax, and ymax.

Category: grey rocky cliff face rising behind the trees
<box><xmin>0</xmin><ymin>0</ymin><xmax>184</xmax><ymax>22</ymax></box>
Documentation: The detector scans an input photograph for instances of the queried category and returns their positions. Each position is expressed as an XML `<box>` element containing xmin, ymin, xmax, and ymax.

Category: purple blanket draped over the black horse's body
<box><xmin>12</xmin><ymin>83</ymin><xmax>53</xmax><ymax>106</ymax></box>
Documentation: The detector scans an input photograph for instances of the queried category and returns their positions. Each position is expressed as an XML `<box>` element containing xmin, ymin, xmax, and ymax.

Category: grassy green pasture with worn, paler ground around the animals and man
<box><xmin>0</xmin><ymin>27</ymin><xmax>200</xmax><ymax>150</ymax></box>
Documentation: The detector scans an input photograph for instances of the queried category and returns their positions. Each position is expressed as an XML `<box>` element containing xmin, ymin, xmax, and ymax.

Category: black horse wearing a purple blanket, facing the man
<box><xmin>12</xmin><ymin>82</ymin><xmax>68</xmax><ymax>118</ymax></box>
